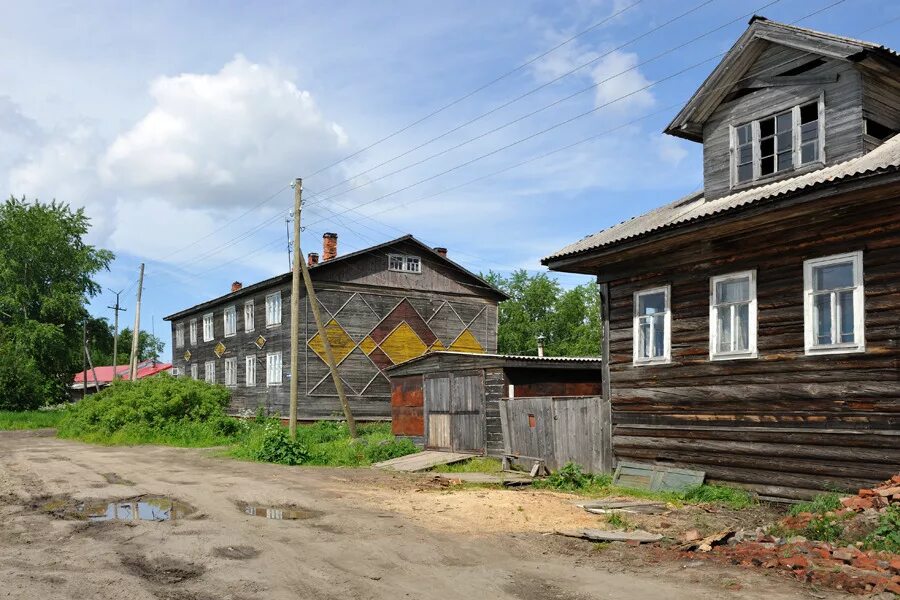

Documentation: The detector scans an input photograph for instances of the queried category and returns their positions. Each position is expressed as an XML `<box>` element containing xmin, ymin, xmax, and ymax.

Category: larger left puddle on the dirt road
<box><xmin>41</xmin><ymin>496</ymin><xmax>194</xmax><ymax>521</ymax></box>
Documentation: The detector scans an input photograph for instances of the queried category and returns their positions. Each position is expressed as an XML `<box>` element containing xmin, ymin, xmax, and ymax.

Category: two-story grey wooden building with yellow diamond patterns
<box><xmin>166</xmin><ymin>233</ymin><xmax>506</xmax><ymax>419</ymax></box>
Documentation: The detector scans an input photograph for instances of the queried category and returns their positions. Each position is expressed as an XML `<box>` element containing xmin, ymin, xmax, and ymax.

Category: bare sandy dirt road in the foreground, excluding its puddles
<box><xmin>0</xmin><ymin>432</ymin><xmax>843</xmax><ymax>600</ymax></box>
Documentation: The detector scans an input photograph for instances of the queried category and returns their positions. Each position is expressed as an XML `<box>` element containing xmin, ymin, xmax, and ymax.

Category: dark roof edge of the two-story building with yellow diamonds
<box><xmin>163</xmin><ymin>233</ymin><xmax>508</xmax><ymax>321</ymax></box>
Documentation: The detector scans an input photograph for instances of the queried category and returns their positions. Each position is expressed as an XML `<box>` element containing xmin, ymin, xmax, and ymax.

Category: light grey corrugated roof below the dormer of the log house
<box><xmin>541</xmin><ymin>135</ymin><xmax>900</xmax><ymax>264</ymax></box>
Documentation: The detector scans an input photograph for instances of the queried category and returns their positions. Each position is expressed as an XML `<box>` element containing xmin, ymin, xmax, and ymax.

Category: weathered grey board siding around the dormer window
<box><xmin>703</xmin><ymin>45</ymin><xmax>864</xmax><ymax>199</ymax></box>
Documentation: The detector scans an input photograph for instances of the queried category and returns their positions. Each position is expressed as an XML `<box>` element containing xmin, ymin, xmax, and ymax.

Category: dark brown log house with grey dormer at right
<box><xmin>543</xmin><ymin>17</ymin><xmax>900</xmax><ymax>497</ymax></box>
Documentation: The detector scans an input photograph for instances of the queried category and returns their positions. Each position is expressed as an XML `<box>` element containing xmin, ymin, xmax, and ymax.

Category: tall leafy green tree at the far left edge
<box><xmin>0</xmin><ymin>198</ymin><xmax>113</xmax><ymax>409</ymax></box>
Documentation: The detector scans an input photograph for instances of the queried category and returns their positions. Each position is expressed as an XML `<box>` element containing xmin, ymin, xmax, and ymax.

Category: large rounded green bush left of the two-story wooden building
<box><xmin>59</xmin><ymin>375</ymin><xmax>232</xmax><ymax>445</ymax></box>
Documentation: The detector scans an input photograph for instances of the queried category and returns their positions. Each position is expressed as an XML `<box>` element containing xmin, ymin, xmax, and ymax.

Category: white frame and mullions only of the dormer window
<box><xmin>728</xmin><ymin>92</ymin><xmax>825</xmax><ymax>188</ymax></box>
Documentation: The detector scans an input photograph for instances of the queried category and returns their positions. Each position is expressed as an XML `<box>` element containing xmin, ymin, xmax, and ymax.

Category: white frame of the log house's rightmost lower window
<box><xmin>803</xmin><ymin>250</ymin><xmax>866</xmax><ymax>355</ymax></box>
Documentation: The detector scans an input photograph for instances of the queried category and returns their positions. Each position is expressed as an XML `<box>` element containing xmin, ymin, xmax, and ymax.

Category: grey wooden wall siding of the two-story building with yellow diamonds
<box><xmin>171</xmin><ymin>259</ymin><xmax>497</xmax><ymax>419</ymax></box>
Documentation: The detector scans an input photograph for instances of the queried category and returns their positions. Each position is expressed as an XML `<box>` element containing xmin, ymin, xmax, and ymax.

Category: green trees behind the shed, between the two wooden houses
<box><xmin>485</xmin><ymin>270</ymin><xmax>600</xmax><ymax>356</ymax></box>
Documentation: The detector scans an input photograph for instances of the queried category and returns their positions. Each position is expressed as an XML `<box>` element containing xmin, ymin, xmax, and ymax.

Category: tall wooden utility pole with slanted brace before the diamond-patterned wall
<box><xmin>290</xmin><ymin>178</ymin><xmax>356</xmax><ymax>438</ymax></box>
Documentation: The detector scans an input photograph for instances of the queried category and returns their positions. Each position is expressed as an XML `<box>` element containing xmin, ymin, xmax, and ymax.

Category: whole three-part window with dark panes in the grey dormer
<box><xmin>731</xmin><ymin>98</ymin><xmax>824</xmax><ymax>186</ymax></box>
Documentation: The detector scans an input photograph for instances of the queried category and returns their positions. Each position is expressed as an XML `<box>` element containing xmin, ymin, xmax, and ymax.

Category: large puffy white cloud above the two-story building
<box><xmin>99</xmin><ymin>56</ymin><xmax>348</xmax><ymax>208</ymax></box>
